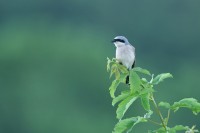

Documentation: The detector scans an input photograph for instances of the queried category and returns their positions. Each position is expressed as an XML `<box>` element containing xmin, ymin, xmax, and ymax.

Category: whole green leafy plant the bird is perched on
<box><xmin>107</xmin><ymin>58</ymin><xmax>200</xmax><ymax>133</ymax></box>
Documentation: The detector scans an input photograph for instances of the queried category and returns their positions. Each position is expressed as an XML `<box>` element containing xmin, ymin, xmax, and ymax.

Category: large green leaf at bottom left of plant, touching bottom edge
<box><xmin>112</xmin><ymin>116</ymin><xmax>147</xmax><ymax>133</ymax></box>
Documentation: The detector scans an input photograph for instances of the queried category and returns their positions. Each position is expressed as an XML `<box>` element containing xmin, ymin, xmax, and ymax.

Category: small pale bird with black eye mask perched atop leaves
<box><xmin>112</xmin><ymin>36</ymin><xmax>135</xmax><ymax>84</ymax></box>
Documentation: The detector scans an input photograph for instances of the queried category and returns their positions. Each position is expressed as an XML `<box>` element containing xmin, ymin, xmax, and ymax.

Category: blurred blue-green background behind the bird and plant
<box><xmin>0</xmin><ymin>0</ymin><xmax>200</xmax><ymax>133</ymax></box>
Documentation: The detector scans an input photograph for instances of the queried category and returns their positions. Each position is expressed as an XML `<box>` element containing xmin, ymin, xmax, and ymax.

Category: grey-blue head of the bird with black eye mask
<box><xmin>112</xmin><ymin>36</ymin><xmax>130</xmax><ymax>47</ymax></box>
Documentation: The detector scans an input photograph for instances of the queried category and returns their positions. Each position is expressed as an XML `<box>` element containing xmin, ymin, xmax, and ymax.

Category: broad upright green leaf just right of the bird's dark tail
<box><xmin>129</xmin><ymin>70</ymin><xmax>141</xmax><ymax>92</ymax></box>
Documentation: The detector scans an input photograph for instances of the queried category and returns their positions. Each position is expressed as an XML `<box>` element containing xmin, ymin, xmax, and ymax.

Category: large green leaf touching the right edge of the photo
<box><xmin>171</xmin><ymin>98</ymin><xmax>200</xmax><ymax>115</ymax></box>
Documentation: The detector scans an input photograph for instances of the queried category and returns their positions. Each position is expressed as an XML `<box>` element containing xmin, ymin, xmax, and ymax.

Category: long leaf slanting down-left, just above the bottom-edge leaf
<box><xmin>116</xmin><ymin>95</ymin><xmax>138</xmax><ymax>119</ymax></box>
